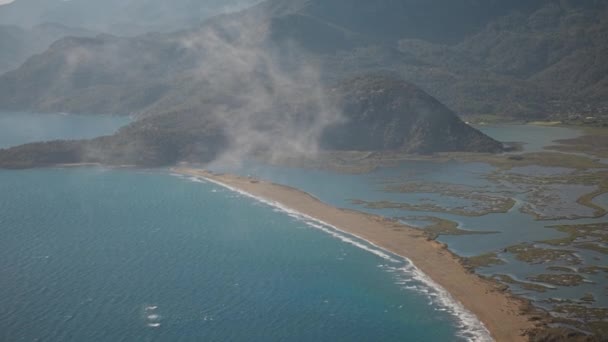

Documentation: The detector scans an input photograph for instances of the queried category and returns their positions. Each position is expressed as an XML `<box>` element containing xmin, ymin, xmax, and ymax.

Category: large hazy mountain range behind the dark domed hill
<box><xmin>268</xmin><ymin>0</ymin><xmax>608</xmax><ymax>119</ymax></box>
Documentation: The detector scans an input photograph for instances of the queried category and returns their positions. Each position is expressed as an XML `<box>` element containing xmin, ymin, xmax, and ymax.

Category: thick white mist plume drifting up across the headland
<box><xmin>163</xmin><ymin>13</ymin><xmax>344</xmax><ymax>165</ymax></box>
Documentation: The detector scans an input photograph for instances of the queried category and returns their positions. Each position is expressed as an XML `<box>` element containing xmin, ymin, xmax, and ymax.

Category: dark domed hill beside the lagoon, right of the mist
<box><xmin>322</xmin><ymin>75</ymin><xmax>502</xmax><ymax>153</ymax></box>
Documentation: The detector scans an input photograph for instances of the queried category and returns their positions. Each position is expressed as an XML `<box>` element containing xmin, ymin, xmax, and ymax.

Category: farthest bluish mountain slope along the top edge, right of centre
<box><xmin>263</xmin><ymin>0</ymin><xmax>544</xmax><ymax>43</ymax></box>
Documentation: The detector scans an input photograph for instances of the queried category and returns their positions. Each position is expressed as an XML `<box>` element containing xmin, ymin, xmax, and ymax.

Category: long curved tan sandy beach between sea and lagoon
<box><xmin>172</xmin><ymin>168</ymin><xmax>535</xmax><ymax>341</ymax></box>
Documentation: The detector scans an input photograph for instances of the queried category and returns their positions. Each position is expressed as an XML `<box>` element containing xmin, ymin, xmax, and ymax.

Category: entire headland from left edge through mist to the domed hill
<box><xmin>0</xmin><ymin>74</ymin><xmax>503</xmax><ymax>168</ymax></box>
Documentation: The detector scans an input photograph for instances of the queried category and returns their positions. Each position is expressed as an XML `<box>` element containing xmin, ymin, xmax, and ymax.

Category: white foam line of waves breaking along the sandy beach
<box><xmin>182</xmin><ymin>178</ymin><xmax>493</xmax><ymax>342</ymax></box>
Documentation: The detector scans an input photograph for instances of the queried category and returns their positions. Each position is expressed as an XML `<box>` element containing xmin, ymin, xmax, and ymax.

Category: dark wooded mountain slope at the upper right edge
<box><xmin>457</xmin><ymin>1</ymin><xmax>608</xmax><ymax>107</ymax></box>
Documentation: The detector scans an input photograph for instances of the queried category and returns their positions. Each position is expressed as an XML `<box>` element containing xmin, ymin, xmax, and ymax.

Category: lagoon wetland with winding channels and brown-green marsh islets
<box><xmin>230</xmin><ymin>125</ymin><xmax>608</xmax><ymax>332</ymax></box>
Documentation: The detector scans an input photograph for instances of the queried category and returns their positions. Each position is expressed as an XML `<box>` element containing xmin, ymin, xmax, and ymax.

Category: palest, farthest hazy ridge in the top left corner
<box><xmin>0</xmin><ymin>0</ymin><xmax>257</xmax><ymax>35</ymax></box>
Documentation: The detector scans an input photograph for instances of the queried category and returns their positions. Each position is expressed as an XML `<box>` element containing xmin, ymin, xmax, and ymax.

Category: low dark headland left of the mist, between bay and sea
<box><xmin>0</xmin><ymin>109</ymin><xmax>227</xmax><ymax>169</ymax></box>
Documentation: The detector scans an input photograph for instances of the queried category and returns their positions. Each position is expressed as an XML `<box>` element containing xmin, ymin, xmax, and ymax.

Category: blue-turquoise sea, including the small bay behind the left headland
<box><xmin>0</xmin><ymin>113</ymin><xmax>490</xmax><ymax>342</ymax></box>
